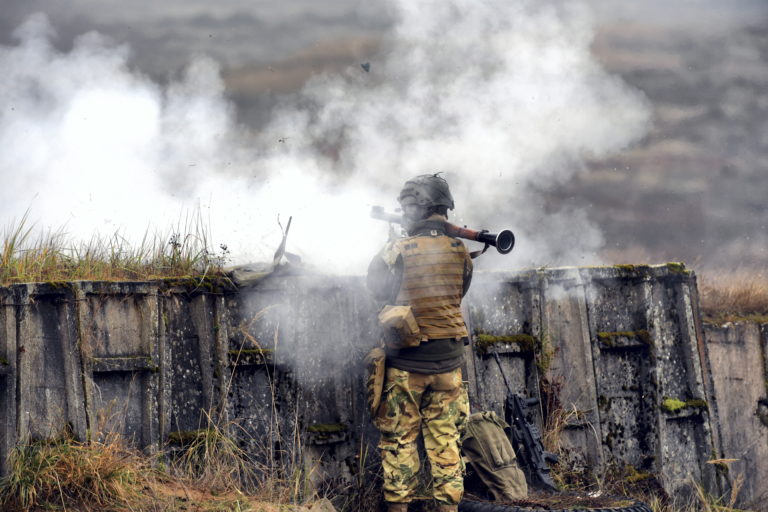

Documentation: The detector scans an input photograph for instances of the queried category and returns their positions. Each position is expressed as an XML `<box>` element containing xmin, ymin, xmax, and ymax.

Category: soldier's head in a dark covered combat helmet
<box><xmin>397</xmin><ymin>173</ymin><xmax>453</xmax><ymax>222</ymax></box>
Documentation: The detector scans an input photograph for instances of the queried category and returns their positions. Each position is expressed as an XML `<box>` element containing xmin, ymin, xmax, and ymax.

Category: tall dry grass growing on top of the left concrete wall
<box><xmin>0</xmin><ymin>213</ymin><xmax>228</xmax><ymax>285</ymax></box>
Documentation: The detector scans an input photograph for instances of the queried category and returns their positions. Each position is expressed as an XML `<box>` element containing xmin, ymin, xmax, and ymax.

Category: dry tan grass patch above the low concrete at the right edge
<box><xmin>699</xmin><ymin>270</ymin><xmax>768</xmax><ymax>323</ymax></box>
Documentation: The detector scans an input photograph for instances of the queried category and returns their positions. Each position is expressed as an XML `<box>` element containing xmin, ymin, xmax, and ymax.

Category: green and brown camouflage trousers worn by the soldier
<box><xmin>374</xmin><ymin>368</ymin><xmax>469</xmax><ymax>504</ymax></box>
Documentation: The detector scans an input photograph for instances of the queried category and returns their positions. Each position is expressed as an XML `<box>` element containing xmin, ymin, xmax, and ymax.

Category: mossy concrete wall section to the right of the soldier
<box><xmin>469</xmin><ymin>265</ymin><xmax>725</xmax><ymax>495</ymax></box>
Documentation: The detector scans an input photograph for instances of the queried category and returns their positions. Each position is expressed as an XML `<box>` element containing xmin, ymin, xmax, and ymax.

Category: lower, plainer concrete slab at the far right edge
<box><xmin>705</xmin><ymin>323</ymin><xmax>768</xmax><ymax>510</ymax></box>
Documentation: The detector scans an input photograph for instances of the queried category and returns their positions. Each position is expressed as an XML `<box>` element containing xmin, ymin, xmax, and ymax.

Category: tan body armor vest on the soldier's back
<box><xmin>397</xmin><ymin>232</ymin><xmax>468</xmax><ymax>340</ymax></box>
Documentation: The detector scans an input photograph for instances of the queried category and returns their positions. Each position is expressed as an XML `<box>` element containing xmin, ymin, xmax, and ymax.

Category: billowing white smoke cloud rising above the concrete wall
<box><xmin>0</xmin><ymin>0</ymin><xmax>649</xmax><ymax>272</ymax></box>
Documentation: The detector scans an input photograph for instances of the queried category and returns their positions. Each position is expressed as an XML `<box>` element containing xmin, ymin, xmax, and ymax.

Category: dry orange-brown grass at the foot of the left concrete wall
<box><xmin>0</xmin><ymin>427</ymin><xmax>340</xmax><ymax>512</ymax></box>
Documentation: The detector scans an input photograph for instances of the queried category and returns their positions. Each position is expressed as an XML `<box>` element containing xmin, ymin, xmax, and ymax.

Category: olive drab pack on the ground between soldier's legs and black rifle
<box><xmin>461</xmin><ymin>411</ymin><xmax>528</xmax><ymax>501</ymax></box>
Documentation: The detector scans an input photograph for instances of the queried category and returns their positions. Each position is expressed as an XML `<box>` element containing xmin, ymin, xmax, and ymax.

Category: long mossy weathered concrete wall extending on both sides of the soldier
<box><xmin>0</xmin><ymin>265</ymin><xmax>759</xmax><ymax>504</ymax></box>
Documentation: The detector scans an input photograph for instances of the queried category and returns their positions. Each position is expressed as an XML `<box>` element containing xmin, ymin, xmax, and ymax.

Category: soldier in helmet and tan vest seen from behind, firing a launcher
<box><xmin>368</xmin><ymin>174</ymin><xmax>472</xmax><ymax>512</ymax></box>
